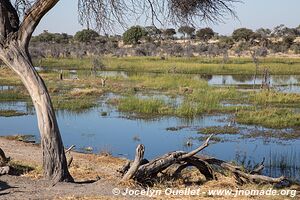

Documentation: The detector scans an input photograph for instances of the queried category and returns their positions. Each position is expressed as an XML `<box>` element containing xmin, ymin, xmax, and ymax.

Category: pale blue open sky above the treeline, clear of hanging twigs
<box><xmin>34</xmin><ymin>0</ymin><xmax>300</xmax><ymax>35</ymax></box>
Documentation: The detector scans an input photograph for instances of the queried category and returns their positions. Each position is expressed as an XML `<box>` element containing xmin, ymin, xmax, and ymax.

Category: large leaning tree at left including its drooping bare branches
<box><xmin>0</xmin><ymin>0</ymin><xmax>236</xmax><ymax>184</ymax></box>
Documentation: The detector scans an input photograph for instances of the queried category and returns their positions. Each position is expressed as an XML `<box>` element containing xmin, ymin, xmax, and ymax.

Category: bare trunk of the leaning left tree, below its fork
<box><xmin>1</xmin><ymin>41</ymin><xmax>73</xmax><ymax>184</ymax></box>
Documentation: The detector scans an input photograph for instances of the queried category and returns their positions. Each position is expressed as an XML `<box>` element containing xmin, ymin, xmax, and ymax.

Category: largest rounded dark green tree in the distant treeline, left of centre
<box><xmin>123</xmin><ymin>26</ymin><xmax>147</xmax><ymax>44</ymax></box>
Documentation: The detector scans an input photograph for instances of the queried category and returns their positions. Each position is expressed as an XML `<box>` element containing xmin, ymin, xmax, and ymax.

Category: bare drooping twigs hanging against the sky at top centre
<box><xmin>78</xmin><ymin>0</ymin><xmax>240</xmax><ymax>32</ymax></box>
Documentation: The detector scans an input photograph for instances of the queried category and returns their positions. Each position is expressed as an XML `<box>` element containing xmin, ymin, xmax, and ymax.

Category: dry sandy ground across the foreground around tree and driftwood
<box><xmin>0</xmin><ymin>137</ymin><xmax>300</xmax><ymax>200</ymax></box>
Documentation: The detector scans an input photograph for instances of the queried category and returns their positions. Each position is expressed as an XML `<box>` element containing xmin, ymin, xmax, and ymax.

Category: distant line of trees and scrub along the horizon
<box><xmin>30</xmin><ymin>25</ymin><xmax>300</xmax><ymax>58</ymax></box>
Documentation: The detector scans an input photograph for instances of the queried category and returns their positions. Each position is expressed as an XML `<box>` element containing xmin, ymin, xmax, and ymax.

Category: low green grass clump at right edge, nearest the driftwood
<box><xmin>236</xmin><ymin>108</ymin><xmax>300</xmax><ymax>128</ymax></box>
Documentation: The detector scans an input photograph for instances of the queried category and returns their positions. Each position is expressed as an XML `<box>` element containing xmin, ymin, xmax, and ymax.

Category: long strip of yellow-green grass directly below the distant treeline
<box><xmin>37</xmin><ymin>57</ymin><xmax>300</xmax><ymax>74</ymax></box>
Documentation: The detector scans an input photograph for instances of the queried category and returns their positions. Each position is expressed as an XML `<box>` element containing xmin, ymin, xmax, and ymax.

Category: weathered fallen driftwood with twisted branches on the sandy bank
<box><xmin>118</xmin><ymin>135</ymin><xmax>287</xmax><ymax>184</ymax></box>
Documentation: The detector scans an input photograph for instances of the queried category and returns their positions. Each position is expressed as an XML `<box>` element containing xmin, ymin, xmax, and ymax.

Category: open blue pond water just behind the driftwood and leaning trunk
<box><xmin>0</xmin><ymin>95</ymin><xmax>300</xmax><ymax>180</ymax></box>
